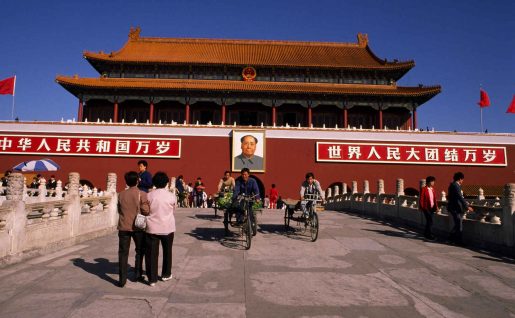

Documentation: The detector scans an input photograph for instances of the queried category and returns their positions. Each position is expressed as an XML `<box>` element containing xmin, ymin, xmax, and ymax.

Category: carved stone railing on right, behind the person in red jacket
<box><xmin>325</xmin><ymin>179</ymin><xmax>515</xmax><ymax>255</ymax></box>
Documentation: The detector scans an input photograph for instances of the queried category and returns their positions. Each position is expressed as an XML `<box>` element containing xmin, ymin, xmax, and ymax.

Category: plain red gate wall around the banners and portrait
<box><xmin>0</xmin><ymin>136</ymin><xmax>515</xmax><ymax>198</ymax></box>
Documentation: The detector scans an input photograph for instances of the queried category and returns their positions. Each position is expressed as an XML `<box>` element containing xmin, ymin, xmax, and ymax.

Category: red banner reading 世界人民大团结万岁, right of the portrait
<box><xmin>316</xmin><ymin>142</ymin><xmax>508</xmax><ymax>166</ymax></box>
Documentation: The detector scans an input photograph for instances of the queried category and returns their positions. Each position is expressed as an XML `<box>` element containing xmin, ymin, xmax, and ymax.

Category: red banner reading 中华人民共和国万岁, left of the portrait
<box><xmin>0</xmin><ymin>135</ymin><xmax>181</xmax><ymax>158</ymax></box>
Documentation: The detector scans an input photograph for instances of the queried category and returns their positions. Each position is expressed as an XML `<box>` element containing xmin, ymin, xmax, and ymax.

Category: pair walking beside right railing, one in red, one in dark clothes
<box><xmin>419</xmin><ymin>172</ymin><xmax>473</xmax><ymax>244</ymax></box>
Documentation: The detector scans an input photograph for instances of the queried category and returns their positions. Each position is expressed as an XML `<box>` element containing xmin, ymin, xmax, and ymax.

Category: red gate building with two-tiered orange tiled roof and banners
<box><xmin>0</xmin><ymin>28</ymin><xmax>515</xmax><ymax>198</ymax></box>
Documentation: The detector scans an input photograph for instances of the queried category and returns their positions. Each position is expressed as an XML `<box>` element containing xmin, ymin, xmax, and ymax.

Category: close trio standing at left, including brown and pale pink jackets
<box><xmin>118</xmin><ymin>160</ymin><xmax>177</xmax><ymax>287</ymax></box>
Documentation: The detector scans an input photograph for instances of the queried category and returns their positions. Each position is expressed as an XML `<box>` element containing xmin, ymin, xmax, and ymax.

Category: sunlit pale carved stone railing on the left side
<box><xmin>0</xmin><ymin>173</ymin><xmax>118</xmax><ymax>265</ymax></box>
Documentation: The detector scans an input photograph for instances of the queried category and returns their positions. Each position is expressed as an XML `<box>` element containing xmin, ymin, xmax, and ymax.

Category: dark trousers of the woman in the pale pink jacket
<box><xmin>145</xmin><ymin>233</ymin><xmax>174</xmax><ymax>283</ymax></box>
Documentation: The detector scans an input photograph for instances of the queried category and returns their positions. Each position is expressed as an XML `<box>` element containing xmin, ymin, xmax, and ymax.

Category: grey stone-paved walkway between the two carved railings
<box><xmin>0</xmin><ymin>209</ymin><xmax>515</xmax><ymax>318</ymax></box>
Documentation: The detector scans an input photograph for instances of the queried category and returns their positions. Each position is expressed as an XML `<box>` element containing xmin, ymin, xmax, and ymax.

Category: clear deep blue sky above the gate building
<box><xmin>0</xmin><ymin>0</ymin><xmax>515</xmax><ymax>133</ymax></box>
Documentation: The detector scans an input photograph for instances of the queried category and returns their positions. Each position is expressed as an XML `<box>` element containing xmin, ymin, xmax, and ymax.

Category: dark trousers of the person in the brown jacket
<box><xmin>118</xmin><ymin>231</ymin><xmax>145</xmax><ymax>286</ymax></box>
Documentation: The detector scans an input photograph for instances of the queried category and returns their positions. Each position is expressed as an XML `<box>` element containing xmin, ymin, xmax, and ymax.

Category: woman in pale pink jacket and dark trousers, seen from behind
<box><xmin>145</xmin><ymin>172</ymin><xmax>177</xmax><ymax>286</ymax></box>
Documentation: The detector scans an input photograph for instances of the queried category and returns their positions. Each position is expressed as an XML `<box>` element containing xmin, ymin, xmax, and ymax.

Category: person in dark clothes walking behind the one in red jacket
<box><xmin>447</xmin><ymin>172</ymin><xmax>473</xmax><ymax>244</ymax></box>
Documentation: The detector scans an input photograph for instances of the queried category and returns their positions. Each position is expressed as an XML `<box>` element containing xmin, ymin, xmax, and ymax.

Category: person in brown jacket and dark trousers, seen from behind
<box><xmin>118</xmin><ymin>171</ymin><xmax>149</xmax><ymax>287</ymax></box>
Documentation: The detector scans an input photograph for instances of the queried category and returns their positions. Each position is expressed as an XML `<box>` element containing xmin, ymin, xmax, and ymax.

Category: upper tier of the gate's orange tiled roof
<box><xmin>84</xmin><ymin>28</ymin><xmax>415</xmax><ymax>70</ymax></box>
